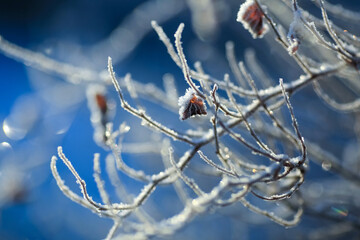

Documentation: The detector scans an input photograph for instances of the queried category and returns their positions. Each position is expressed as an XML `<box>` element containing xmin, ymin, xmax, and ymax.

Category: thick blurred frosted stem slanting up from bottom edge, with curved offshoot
<box><xmin>124</xmin><ymin>163</ymin><xmax>302</xmax><ymax>238</ymax></box>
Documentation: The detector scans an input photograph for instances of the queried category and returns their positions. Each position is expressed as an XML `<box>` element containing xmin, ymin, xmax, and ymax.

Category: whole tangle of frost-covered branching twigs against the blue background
<box><xmin>0</xmin><ymin>0</ymin><xmax>360</xmax><ymax>239</ymax></box>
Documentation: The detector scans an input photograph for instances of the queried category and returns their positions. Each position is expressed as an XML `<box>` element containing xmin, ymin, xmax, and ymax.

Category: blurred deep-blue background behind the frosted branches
<box><xmin>0</xmin><ymin>0</ymin><xmax>360</xmax><ymax>239</ymax></box>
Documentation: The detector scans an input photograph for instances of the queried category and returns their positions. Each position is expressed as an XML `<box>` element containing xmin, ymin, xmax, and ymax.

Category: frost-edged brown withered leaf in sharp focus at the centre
<box><xmin>178</xmin><ymin>88</ymin><xmax>207</xmax><ymax>120</ymax></box>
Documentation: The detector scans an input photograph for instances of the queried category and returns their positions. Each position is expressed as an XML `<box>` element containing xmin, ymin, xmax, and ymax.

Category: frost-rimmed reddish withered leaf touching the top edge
<box><xmin>236</xmin><ymin>0</ymin><xmax>269</xmax><ymax>38</ymax></box>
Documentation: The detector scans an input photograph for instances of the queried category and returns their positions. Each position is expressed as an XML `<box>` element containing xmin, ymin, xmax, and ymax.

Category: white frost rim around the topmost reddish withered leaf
<box><xmin>236</xmin><ymin>0</ymin><xmax>269</xmax><ymax>38</ymax></box>
